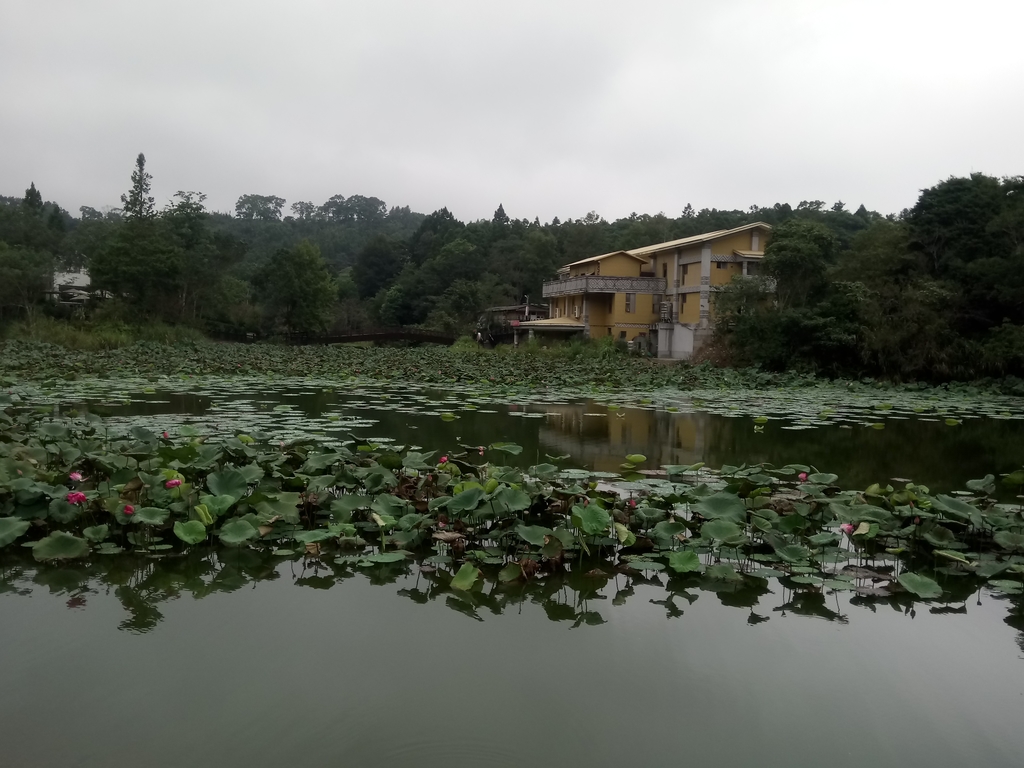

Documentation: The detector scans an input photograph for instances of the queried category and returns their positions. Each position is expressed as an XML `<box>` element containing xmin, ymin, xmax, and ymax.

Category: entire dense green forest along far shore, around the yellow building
<box><xmin>0</xmin><ymin>155</ymin><xmax>1024</xmax><ymax>380</ymax></box>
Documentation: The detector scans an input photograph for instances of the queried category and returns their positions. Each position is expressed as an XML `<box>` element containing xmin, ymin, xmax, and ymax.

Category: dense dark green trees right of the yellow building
<box><xmin>716</xmin><ymin>174</ymin><xmax>1024</xmax><ymax>380</ymax></box>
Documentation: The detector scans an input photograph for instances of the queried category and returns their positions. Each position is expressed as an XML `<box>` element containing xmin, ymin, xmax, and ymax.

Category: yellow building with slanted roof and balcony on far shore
<box><xmin>522</xmin><ymin>221</ymin><xmax>771</xmax><ymax>359</ymax></box>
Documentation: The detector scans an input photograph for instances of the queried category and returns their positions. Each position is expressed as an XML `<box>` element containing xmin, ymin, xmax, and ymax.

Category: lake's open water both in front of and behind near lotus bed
<box><xmin>0</xmin><ymin>377</ymin><xmax>1024</xmax><ymax>768</ymax></box>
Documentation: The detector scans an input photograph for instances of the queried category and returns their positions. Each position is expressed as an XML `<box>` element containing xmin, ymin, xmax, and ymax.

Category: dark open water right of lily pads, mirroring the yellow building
<box><xmin>538</xmin><ymin>402</ymin><xmax>1024</xmax><ymax>489</ymax></box>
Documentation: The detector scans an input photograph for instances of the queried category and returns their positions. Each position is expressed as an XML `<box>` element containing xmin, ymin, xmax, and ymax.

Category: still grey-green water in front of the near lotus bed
<box><xmin>0</xmin><ymin>552</ymin><xmax>1024</xmax><ymax>768</ymax></box>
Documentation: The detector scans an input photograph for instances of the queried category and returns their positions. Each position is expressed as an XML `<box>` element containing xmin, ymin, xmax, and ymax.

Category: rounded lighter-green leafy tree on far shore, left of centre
<box><xmin>257</xmin><ymin>240</ymin><xmax>338</xmax><ymax>333</ymax></box>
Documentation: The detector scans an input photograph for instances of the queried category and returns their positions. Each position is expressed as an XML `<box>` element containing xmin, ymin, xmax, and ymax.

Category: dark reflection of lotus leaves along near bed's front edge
<box><xmin>0</xmin><ymin>549</ymin><xmax>1024</xmax><ymax>649</ymax></box>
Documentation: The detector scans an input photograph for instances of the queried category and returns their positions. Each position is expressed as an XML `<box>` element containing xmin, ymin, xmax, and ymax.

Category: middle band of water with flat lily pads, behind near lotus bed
<box><xmin>25</xmin><ymin>377</ymin><xmax>1024</xmax><ymax>490</ymax></box>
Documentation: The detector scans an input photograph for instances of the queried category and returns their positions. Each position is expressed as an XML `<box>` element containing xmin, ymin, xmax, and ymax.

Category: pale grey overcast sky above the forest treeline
<box><xmin>0</xmin><ymin>0</ymin><xmax>1024</xmax><ymax>221</ymax></box>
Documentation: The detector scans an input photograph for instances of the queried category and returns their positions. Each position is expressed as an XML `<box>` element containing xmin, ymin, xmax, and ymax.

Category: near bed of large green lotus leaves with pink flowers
<box><xmin>0</xmin><ymin>391</ymin><xmax>1024</xmax><ymax>618</ymax></box>
